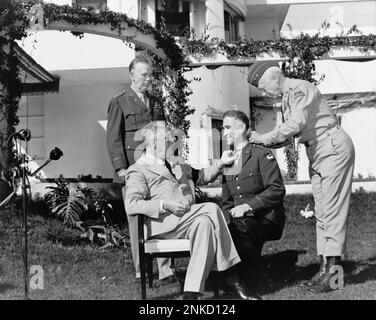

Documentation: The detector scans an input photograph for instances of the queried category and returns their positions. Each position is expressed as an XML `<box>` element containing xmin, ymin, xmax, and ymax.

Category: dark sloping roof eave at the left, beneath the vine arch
<box><xmin>14</xmin><ymin>43</ymin><xmax>59</xmax><ymax>95</ymax></box>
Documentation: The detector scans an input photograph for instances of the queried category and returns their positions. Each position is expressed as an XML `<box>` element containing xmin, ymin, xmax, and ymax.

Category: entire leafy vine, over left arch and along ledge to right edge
<box><xmin>0</xmin><ymin>0</ymin><xmax>376</xmax><ymax>181</ymax></box>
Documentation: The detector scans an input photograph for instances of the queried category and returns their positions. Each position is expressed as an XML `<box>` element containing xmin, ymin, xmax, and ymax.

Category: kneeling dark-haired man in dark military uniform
<box><xmin>222</xmin><ymin>110</ymin><xmax>285</xmax><ymax>292</ymax></box>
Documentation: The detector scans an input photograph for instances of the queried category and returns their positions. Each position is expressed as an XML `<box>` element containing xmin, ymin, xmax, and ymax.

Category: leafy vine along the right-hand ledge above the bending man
<box><xmin>182</xmin><ymin>24</ymin><xmax>376</xmax><ymax>180</ymax></box>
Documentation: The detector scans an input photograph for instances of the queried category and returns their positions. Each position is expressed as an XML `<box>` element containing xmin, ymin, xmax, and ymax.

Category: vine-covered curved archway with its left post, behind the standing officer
<box><xmin>0</xmin><ymin>0</ymin><xmax>193</xmax><ymax>194</ymax></box>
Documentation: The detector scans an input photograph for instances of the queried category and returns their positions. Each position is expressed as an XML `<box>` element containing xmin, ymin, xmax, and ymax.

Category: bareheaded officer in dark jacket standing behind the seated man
<box><xmin>107</xmin><ymin>58</ymin><xmax>173</xmax><ymax>279</ymax></box>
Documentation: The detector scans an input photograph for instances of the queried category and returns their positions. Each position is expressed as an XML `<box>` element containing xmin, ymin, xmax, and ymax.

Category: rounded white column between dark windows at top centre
<box><xmin>205</xmin><ymin>0</ymin><xmax>225</xmax><ymax>39</ymax></box>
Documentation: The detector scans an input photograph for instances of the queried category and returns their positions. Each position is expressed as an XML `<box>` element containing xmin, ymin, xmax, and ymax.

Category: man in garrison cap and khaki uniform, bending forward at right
<box><xmin>248</xmin><ymin>62</ymin><xmax>355</xmax><ymax>292</ymax></box>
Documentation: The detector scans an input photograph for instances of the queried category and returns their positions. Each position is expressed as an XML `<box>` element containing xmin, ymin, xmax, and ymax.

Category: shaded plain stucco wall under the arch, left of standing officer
<box><xmin>25</xmin><ymin>68</ymin><xmax>130</xmax><ymax>178</ymax></box>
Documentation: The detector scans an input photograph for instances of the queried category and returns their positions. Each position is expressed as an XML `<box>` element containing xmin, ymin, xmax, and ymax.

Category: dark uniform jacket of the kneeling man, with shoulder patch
<box><xmin>222</xmin><ymin>143</ymin><xmax>286</xmax><ymax>231</ymax></box>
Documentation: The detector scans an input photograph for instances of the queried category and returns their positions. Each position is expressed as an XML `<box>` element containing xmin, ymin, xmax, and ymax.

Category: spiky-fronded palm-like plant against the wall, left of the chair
<box><xmin>44</xmin><ymin>178</ymin><xmax>88</xmax><ymax>227</ymax></box>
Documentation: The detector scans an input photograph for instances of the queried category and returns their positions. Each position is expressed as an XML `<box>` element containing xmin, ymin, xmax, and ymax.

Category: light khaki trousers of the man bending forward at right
<box><xmin>306</xmin><ymin>128</ymin><xmax>355</xmax><ymax>257</ymax></box>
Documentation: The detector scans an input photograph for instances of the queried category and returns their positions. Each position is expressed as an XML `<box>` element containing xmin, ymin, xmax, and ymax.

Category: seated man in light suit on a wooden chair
<box><xmin>125</xmin><ymin>121</ymin><xmax>253</xmax><ymax>300</ymax></box>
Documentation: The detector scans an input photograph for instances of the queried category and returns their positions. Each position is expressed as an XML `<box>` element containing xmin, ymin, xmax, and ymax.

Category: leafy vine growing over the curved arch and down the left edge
<box><xmin>0</xmin><ymin>0</ymin><xmax>194</xmax><ymax>182</ymax></box>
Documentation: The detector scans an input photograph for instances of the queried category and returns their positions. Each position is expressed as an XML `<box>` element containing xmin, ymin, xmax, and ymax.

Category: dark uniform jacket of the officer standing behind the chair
<box><xmin>107</xmin><ymin>87</ymin><xmax>165</xmax><ymax>183</ymax></box>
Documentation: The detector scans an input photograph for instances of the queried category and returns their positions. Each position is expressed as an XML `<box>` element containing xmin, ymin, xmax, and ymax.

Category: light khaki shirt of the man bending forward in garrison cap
<box><xmin>264</xmin><ymin>78</ymin><xmax>337</xmax><ymax>145</ymax></box>
